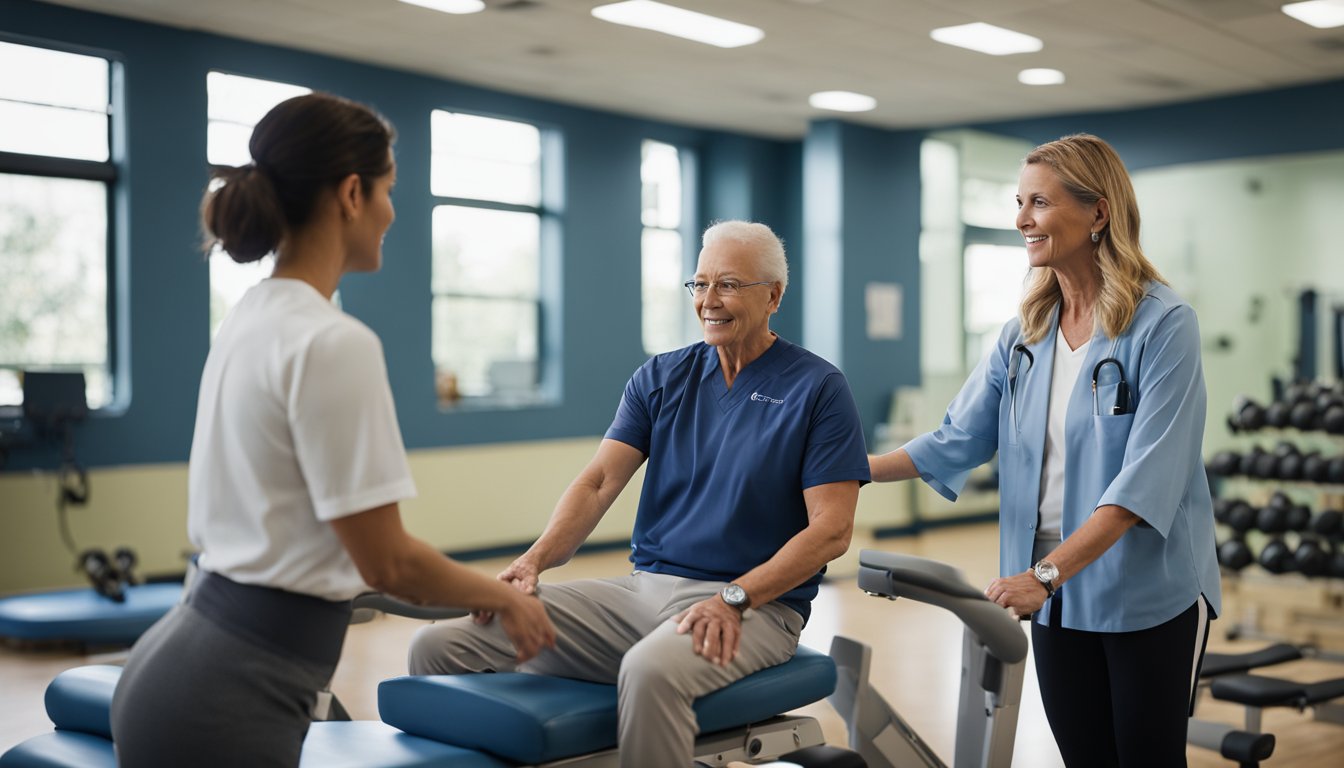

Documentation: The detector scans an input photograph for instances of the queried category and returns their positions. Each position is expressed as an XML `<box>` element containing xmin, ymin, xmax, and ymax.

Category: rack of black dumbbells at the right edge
<box><xmin>1211</xmin><ymin>385</ymin><xmax>1344</xmax><ymax>648</ymax></box>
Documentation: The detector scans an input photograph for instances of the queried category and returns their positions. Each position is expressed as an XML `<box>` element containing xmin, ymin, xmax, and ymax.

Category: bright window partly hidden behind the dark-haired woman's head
<box><xmin>206</xmin><ymin>73</ymin><xmax>310</xmax><ymax>339</ymax></box>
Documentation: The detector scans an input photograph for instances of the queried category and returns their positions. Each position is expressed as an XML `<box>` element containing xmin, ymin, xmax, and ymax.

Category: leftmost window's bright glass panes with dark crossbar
<box><xmin>0</xmin><ymin>42</ymin><xmax>117</xmax><ymax>408</ymax></box>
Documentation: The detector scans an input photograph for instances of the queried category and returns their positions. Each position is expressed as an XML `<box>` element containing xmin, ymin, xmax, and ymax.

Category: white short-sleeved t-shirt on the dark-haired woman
<box><xmin>187</xmin><ymin>278</ymin><xmax>415</xmax><ymax>600</ymax></box>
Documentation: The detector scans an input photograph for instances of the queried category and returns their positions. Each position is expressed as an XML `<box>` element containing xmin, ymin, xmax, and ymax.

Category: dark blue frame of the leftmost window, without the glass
<box><xmin>0</xmin><ymin>31</ymin><xmax>122</xmax><ymax>416</ymax></box>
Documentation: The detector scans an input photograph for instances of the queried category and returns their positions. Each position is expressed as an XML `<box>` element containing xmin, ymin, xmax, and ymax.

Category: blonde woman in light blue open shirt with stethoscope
<box><xmin>870</xmin><ymin>135</ymin><xmax>1222</xmax><ymax>767</ymax></box>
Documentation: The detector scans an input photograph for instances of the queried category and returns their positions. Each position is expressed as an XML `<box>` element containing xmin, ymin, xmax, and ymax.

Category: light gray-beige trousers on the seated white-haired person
<box><xmin>409</xmin><ymin>572</ymin><xmax>802</xmax><ymax>768</ymax></box>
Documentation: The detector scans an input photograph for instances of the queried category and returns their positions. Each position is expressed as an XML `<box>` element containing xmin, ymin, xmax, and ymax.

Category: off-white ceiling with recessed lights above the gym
<box><xmin>34</xmin><ymin>0</ymin><xmax>1344</xmax><ymax>137</ymax></box>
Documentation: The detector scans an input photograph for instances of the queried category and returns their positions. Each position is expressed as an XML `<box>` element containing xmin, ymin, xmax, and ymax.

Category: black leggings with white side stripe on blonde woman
<box><xmin>1031</xmin><ymin>597</ymin><xmax>1208</xmax><ymax>768</ymax></box>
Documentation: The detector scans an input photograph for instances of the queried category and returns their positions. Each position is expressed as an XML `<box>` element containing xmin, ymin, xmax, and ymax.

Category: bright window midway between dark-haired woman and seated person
<box><xmin>430</xmin><ymin>110</ymin><xmax>547</xmax><ymax>405</ymax></box>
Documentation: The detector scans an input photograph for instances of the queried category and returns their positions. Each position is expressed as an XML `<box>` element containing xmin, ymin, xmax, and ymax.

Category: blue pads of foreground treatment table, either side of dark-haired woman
<box><xmin>0</xmin><ymin>646</ymin><xmax>836</xmax><ymax>768</ymax></box>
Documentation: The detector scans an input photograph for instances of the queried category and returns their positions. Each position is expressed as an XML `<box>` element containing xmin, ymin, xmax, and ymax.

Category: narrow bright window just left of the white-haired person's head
<box><xmin>640</xmin><ymin>141</ymin><xmax>695</xmax><ymax>355</ymax></box>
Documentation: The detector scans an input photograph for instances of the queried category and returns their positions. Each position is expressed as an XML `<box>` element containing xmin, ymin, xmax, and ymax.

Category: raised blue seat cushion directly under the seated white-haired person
<box><xmin>378</xmin><ymin>646</ymin><xmax>836</xmax><ymax>764</ymax></box>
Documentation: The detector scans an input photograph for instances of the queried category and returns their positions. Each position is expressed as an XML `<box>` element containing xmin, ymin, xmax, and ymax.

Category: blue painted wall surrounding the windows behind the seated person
<box><xmin>0</xmin><ymin>0</ymin><xmax>801</xmax><ymax>469</ymax></box>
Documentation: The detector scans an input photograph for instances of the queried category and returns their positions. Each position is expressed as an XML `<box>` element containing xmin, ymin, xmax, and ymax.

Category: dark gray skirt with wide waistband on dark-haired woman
<box><xmin>112</xmin><ymin>573</ymin><xmax>349</xmax><ymax>768</ymax></box>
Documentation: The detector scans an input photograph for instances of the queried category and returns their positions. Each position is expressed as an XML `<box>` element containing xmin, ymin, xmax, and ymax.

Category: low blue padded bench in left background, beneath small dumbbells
<box><xmin>0</xmin><ymin>582</ymin><xmax>181</xmax><ymax>646</ymax></box>
